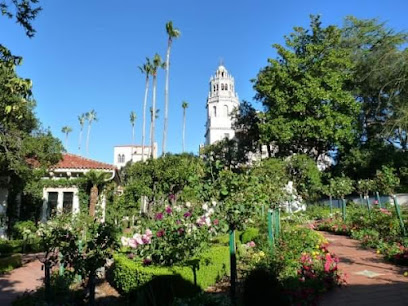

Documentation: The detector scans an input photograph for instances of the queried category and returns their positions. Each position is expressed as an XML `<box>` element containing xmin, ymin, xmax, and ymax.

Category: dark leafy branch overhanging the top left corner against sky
<box><xmin>0</xmin><ymin>0</ymin><xmax>42</xmax><ymax>38</ymax></box>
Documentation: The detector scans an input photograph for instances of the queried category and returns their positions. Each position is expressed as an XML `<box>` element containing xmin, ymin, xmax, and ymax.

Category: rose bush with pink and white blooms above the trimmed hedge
<box><xmin>121</xmin><ymin>201</ymin><xmax>220</xmax><ymax>265</ymax></box>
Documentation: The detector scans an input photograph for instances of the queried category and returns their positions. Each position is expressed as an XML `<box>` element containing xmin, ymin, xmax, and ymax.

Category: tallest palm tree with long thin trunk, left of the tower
<box><xmin>162</xmin><ymin>21</ymin><xmax>180</xmax><ymax>155</ymax></box>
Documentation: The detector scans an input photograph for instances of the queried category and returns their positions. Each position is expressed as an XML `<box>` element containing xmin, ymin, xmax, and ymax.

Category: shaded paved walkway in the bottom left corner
<box><xmin>0</xmin><ymin>254</ymin><xmax>44</xmax><ymax>306</ymax></box>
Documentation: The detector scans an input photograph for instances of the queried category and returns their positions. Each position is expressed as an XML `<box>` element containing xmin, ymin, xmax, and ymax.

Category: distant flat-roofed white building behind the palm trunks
<box><xmin>113</xmin><ymin>142</ymin><xmax>157</xmax><ymax>169</ymax></box>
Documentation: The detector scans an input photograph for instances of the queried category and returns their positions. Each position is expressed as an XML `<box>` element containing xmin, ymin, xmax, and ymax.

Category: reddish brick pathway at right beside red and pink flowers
<box><xmin>319</xmin><ymin>232</ymin><xmax>408</xmax><ymax>306</ymax></box>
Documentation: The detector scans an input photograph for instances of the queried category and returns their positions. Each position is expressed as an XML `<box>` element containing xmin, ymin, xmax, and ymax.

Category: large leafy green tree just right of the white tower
<box><xmin>254</xmin><ymin>16</ymin><xmax>359</xmax><ymax>160</ymax></box>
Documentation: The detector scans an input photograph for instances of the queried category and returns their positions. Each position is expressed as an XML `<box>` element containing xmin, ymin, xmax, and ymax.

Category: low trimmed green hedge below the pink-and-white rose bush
<box><xmin>110</xmin><ymin>245</ymin><xmax>229</xmax><ymax>304</ymax></box>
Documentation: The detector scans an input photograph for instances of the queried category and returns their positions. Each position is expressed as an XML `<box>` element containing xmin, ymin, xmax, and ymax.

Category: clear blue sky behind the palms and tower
<box><xmin>0</xmin><ymin>0</ymin><xmax>408</xmax><ymax>163</ymax></box>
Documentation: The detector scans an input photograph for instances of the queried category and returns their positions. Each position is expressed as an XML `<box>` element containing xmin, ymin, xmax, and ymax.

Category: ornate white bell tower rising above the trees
<box><xmin>205</xmin><ymin>64</ymin><xmax>239</xmax><ymax>145</ymax></box>
